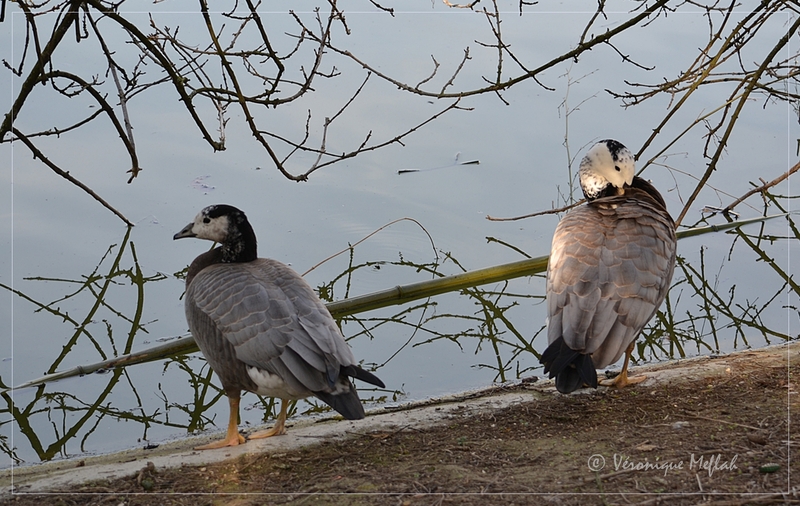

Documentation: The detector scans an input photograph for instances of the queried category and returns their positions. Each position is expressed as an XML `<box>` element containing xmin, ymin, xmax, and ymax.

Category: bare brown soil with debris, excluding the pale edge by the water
<box><xmin>3</xmin><ymin>348</ymin><xmax>800</xmax><ymax>506</ymax></box>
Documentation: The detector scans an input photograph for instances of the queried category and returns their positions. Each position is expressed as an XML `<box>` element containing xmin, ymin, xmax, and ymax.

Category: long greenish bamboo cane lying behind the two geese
<box><xmin>0</xmin><ymin>213</ymin><xmax>789</xmax><ymax>393</ymax></box>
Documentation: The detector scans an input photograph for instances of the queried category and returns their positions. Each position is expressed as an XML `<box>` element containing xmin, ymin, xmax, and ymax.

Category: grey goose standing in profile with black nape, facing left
<box><xmin>173</xmin><ymin>204</ymin><xmax>384</xmax><ymax>450</ymax></box>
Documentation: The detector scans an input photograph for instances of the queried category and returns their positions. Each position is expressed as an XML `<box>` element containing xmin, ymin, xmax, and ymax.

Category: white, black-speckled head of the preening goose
<box><xmin>578</xmin><ymin>139</ymin><xmax>636</xmax><ymax>200</ymax></box>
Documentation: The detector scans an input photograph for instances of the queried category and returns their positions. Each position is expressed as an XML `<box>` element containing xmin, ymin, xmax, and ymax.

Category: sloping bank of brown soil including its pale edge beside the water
<box><xmin>0</xmin><ymin>345</ymin><xmax>800</xmax><ymax>506</ymax></box>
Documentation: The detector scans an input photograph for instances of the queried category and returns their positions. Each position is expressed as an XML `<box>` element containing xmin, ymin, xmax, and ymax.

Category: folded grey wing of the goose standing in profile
<box><xmin>186</xmin><ymin>259</ymin><xmax>355</xmax><ymax>394</ymax></box>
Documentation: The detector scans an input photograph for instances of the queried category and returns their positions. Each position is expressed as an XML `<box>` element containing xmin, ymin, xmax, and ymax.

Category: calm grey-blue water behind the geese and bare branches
<box><xmin>0</xmin><ymin>2</ymin><xmax>798</xmax><ymax>466</ymax></box>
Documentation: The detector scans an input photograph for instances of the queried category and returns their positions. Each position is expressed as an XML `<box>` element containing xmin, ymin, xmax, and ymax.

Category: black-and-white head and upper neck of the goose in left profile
<box><xmin>172</xmin><ymin>204</ymin><xmax>257</xmax><ymax>262</ymax></box>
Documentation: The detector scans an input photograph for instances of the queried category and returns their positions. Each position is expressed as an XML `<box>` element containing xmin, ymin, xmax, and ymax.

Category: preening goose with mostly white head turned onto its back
<box><xmin>541</xmin><ymin>139</ymin><xmax>677</xmax><ymax>393</ymax></box>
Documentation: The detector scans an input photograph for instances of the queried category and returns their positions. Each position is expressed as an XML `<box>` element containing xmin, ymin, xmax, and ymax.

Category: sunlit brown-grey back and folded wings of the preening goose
<box><xmin>547</xmin><ymin>188</ymin><xmax>676</xmax><ymax>368</ymax></box>
